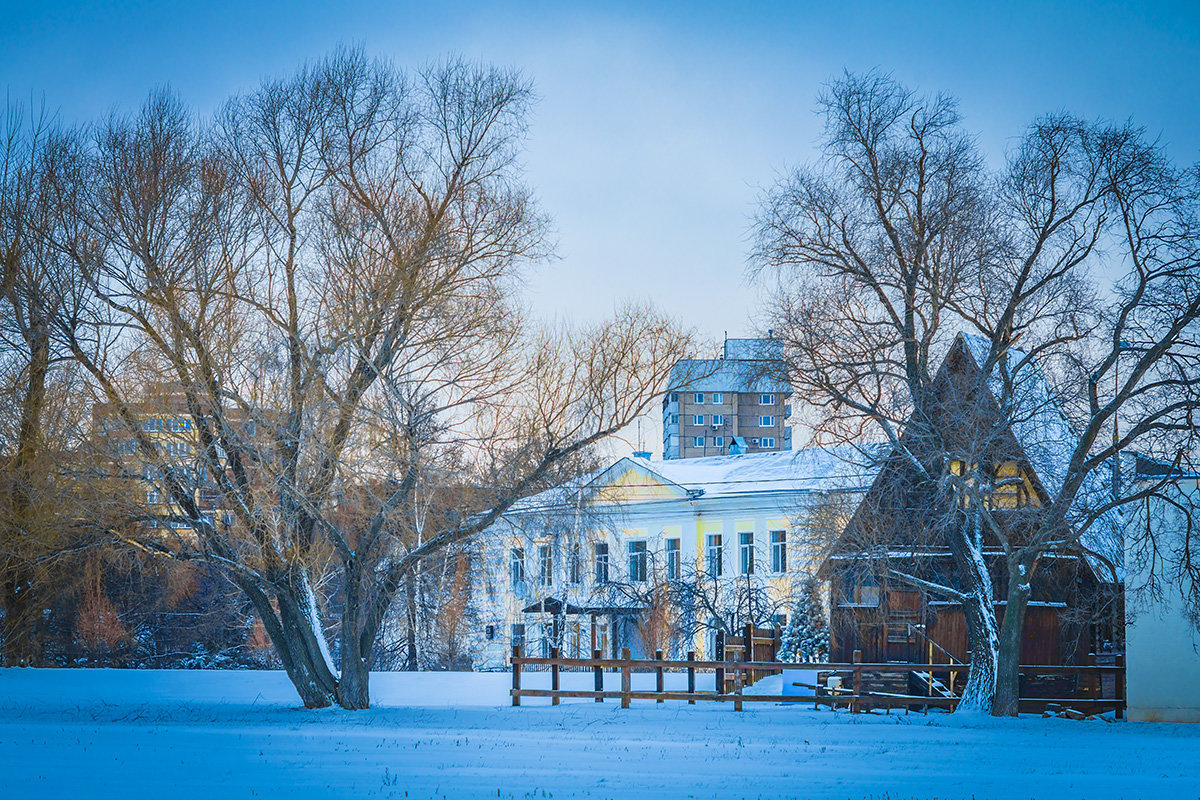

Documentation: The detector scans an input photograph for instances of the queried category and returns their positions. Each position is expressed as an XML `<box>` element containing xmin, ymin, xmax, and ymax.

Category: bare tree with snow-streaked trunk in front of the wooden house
<box><xmin>755</xmin><ymin>74</ymin><xmax>1198</xmax><ymax>714</ymax></box>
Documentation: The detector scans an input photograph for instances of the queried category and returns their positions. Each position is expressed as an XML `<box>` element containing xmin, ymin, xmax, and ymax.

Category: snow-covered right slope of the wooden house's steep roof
<box><xmin>959</xmin><ymin>333</ymin><xmax>1124</xmax><ymax>581</ymax></box>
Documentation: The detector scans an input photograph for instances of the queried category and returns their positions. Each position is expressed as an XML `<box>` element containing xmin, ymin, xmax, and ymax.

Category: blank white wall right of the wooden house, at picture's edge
<box><xmin>1126</xmin><ymin>480</ymin><xmax>1200</xmax><ymax>722</ymax></box>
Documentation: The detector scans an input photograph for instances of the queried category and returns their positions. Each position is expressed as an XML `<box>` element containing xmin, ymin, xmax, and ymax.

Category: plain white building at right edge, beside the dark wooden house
<box><xmin>1126</xmin><ymin>462</ymin><xmax>1200</xmax><ymax>722</ymax></box>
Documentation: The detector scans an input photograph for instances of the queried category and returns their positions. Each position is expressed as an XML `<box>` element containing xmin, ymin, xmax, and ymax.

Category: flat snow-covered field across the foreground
<box><xmin>0</xmin><ymin>669</ymin><xmax>1200</xmax><ymax>800</ymax></box>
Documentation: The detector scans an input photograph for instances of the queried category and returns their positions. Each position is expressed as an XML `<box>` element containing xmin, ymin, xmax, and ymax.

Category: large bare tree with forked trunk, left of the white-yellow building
<box><xmin>51</xmin><ymin>50</ymin><xmax>686</xmax><ymax>709</ymax></box>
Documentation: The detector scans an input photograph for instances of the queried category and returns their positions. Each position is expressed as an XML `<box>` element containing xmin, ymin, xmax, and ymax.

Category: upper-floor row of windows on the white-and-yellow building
<box><xmin>509</xmin><ymin>530</ymin><xmax>787</xmax><ymax>587</ymax></box>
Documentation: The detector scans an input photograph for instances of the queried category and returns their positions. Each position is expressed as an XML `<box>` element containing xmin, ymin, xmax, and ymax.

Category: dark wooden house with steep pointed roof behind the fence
<box><xmin>822</xmin><ymin>335</ymin><xmax>1122</xmax><ymax>664</ymax></box>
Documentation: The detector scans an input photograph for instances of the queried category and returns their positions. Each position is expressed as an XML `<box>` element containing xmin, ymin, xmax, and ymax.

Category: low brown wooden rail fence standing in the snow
<box><xmin>510</xmin><ymin>645</ymin><xmax>1126</xmax><ymax>717</ymax></box>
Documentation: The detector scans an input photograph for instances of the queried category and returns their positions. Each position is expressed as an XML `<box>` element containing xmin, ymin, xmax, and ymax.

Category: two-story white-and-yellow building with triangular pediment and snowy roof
<box><xmin>473</xmin><ymin>447</ymin><xmax>871</xmax><ymax>668</ymax></box>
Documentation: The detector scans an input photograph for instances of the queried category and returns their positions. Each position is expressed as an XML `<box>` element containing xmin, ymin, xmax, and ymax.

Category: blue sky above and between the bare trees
<box><xmin>0</xmin><ymin>0</ymin><xmax>1200</xmax><ymax>350</ymax></box>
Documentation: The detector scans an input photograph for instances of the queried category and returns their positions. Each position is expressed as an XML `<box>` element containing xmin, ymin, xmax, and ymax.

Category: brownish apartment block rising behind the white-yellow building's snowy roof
<box><xmin>662</xmin><ymin>339</ymin><xmax>792</xmax><ymax>459</ymax></box>
